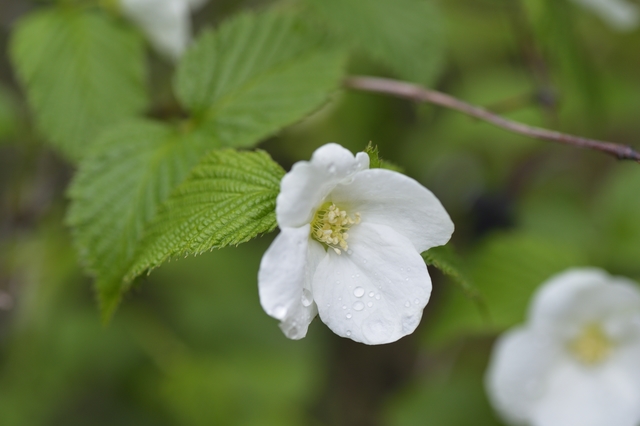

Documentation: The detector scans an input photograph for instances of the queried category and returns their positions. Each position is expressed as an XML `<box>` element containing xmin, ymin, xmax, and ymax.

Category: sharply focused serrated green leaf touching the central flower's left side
<box><xmin>127</xmin><ymin>150</ymin><xmax>284</xmax><ymax>279</ymax></box>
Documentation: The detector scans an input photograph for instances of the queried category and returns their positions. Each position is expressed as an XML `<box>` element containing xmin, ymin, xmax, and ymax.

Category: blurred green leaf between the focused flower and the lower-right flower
<box><xmin>428</xmin><ymin>232</ymin><xmax>589</xmax><ymax>345</ymax></box>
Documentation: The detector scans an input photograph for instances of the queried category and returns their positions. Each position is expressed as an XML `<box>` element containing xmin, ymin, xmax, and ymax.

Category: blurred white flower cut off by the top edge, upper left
<box><xmin>120</xmin><ymin>0</ymin><xmax>207</xmax><ymax>61</ymax></box>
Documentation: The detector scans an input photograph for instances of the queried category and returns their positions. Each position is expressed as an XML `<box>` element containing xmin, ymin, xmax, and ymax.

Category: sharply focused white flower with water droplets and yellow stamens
<box><xmin>258</xmin><ymin>144</ymin><xmax>453</xmax><ymax>344</ymax></box>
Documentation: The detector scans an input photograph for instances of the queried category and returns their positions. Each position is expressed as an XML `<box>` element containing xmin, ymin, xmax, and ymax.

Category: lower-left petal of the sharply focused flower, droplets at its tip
<box><xmin>258</xmin><ymin>225</ymin><xmax>326</xmax><ymax>339</ymax></box>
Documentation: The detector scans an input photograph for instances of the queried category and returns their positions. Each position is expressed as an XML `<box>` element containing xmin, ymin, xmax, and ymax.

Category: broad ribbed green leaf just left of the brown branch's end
<box><xmin>175</xmin><ymin>13</ymin><xmax>344</xmax><ymax>147</ymax></box>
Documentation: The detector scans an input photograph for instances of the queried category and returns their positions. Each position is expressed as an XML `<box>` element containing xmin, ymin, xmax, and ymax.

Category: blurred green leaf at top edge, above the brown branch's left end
<box><xmin>307</xmin><ymin>0</ymin><xmax>444</xmax><ymax>85</ymax></box>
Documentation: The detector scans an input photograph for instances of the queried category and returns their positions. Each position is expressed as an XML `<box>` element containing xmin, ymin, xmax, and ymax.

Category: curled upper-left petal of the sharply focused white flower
<box><xmin>276</xmin><ymin>143</ymin><xmax>369</xmax><ymax>228</ymax></box>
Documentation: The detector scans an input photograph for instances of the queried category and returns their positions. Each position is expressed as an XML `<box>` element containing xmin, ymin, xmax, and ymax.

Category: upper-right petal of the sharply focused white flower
<box><xmin>330</xmin><ymin>169</ymin><xmax>453</xmax><ymax>253</ymax></box>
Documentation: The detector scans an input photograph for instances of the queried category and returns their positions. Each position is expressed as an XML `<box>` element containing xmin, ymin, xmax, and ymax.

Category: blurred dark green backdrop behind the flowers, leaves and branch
<box><xmin>0</xmin><ymin>0</ymin><xmax>640</xmax><ymax>426</ymax></box>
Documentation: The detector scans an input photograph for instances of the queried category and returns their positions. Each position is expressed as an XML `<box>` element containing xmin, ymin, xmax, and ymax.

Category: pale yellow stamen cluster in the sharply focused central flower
<box><xmin>311</xmin><ymin>202</ymin><xmax>360</xmax><ymax>254</ymax></box>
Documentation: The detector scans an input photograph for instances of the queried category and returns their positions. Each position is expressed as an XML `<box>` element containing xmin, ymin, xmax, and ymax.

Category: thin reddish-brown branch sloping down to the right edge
<box><xmin>344</xmin><ymin>76</ymin><xmax>640</xmax><ymax>163</ymax></box>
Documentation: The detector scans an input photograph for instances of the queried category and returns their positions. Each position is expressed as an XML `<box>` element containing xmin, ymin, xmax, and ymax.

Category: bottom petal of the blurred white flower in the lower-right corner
<box><xmin>532</xmin><ymin>359</ymin><xmax>640</xmax><ymax>426</ymax></box>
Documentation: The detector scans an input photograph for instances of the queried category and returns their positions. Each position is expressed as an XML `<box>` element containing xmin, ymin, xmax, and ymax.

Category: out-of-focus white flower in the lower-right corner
<box><xmin>486</xmin><ymin>268</ymin><xmax>640</xmax><ymax>426</ymax></box>
